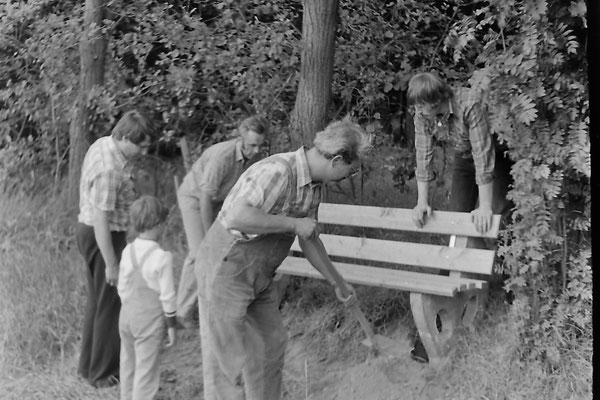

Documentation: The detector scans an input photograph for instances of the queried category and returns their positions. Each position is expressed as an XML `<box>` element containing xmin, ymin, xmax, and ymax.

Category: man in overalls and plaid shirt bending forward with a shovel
<box><xmin>196</xmin><ymin>119</ymin><xmax>370</xmax><ymax>400</ymax></box>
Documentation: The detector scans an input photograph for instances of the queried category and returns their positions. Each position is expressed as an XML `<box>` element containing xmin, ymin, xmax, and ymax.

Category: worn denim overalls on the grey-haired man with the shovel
<box><xmin>196</xmin><ymin>158</ymin><xmax>316</xmax><ymax>400</ymax></box>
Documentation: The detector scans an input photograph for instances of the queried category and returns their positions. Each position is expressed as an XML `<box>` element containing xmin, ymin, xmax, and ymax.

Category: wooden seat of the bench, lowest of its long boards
<box><xmin>277</xmin><ymin>257</ymin><xmax>487</xmax><ymax>297</ymax></box>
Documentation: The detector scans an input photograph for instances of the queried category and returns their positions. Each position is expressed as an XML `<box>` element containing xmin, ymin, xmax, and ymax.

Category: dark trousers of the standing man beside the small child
<box><xmin>77</xmin><ymin>224</ymin><xmax>127</xmax><ymax>386</ymax></box>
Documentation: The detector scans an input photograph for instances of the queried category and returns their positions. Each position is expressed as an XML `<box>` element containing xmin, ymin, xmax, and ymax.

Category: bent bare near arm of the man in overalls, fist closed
<box><xmin>227</xmin><ymin>200</ymin><xmax>318</xmax><ymax>238</ymax></box>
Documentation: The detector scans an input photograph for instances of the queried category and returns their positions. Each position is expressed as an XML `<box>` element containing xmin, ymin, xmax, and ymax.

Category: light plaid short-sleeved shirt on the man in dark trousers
<box><xmin>78</xmin><ymin>136</ymin><xmax>135</xmax><ymax>232</ymax></box>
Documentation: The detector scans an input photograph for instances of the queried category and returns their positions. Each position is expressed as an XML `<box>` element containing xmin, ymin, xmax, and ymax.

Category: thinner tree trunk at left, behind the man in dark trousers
<box><xmin>68</xmin><ymin>0</ymin><xmax>107</xmax><ymax>204</ymax></box>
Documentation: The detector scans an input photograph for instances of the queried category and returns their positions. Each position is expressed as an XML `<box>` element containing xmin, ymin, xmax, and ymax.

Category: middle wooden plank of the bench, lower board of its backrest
<box><xmin>292</xmin><ymin>234</ymin><xmax>495</xmax><ymax>275</ymax></box>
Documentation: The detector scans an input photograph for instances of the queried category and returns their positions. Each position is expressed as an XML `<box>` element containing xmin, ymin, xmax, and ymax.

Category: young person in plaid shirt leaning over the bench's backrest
<box><xmin>408</xmin><ymin>72</ymin><xmax>512</xmax><ymax>362</ymax></box>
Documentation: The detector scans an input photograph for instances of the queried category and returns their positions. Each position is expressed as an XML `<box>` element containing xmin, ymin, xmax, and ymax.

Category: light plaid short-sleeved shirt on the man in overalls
<box><xmin>217</xmin><ymin>147</ymin><xmax>322</xmax><ymax>238</ymax></box>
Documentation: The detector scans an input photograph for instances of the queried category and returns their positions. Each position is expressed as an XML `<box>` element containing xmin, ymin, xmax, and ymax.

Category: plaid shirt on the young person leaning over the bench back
<box><xmin>414</xmin><ymin>88</ymin><xmax>496</xmax><ymax>185</ymax></box>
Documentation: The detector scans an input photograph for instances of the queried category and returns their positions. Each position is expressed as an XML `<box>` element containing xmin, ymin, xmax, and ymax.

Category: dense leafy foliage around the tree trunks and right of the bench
<box><xmin>0</xmin><ymin>0</ymin><xmax>592</xmax><ymax>374</ymax></box>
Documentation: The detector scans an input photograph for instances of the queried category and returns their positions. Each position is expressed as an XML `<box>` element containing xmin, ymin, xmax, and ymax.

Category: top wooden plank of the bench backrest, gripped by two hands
<box><xmin>319</xmin><ymin>203</ymin><xmax>500</xmax><ymax>239</ymax></box>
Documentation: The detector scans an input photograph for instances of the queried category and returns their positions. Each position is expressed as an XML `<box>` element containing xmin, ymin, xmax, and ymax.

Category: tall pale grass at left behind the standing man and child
<box><xmin>0</xmin><ymin>179</ymin><xmax>185</xmax><ymax>400</ymax></box>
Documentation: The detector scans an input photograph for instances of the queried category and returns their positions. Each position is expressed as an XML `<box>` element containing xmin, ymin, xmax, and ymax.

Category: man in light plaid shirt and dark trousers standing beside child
<box><xmin>77</xmin><ymin>110</ymin><xmax>152</xmax><ymax>387</ymax></box>
